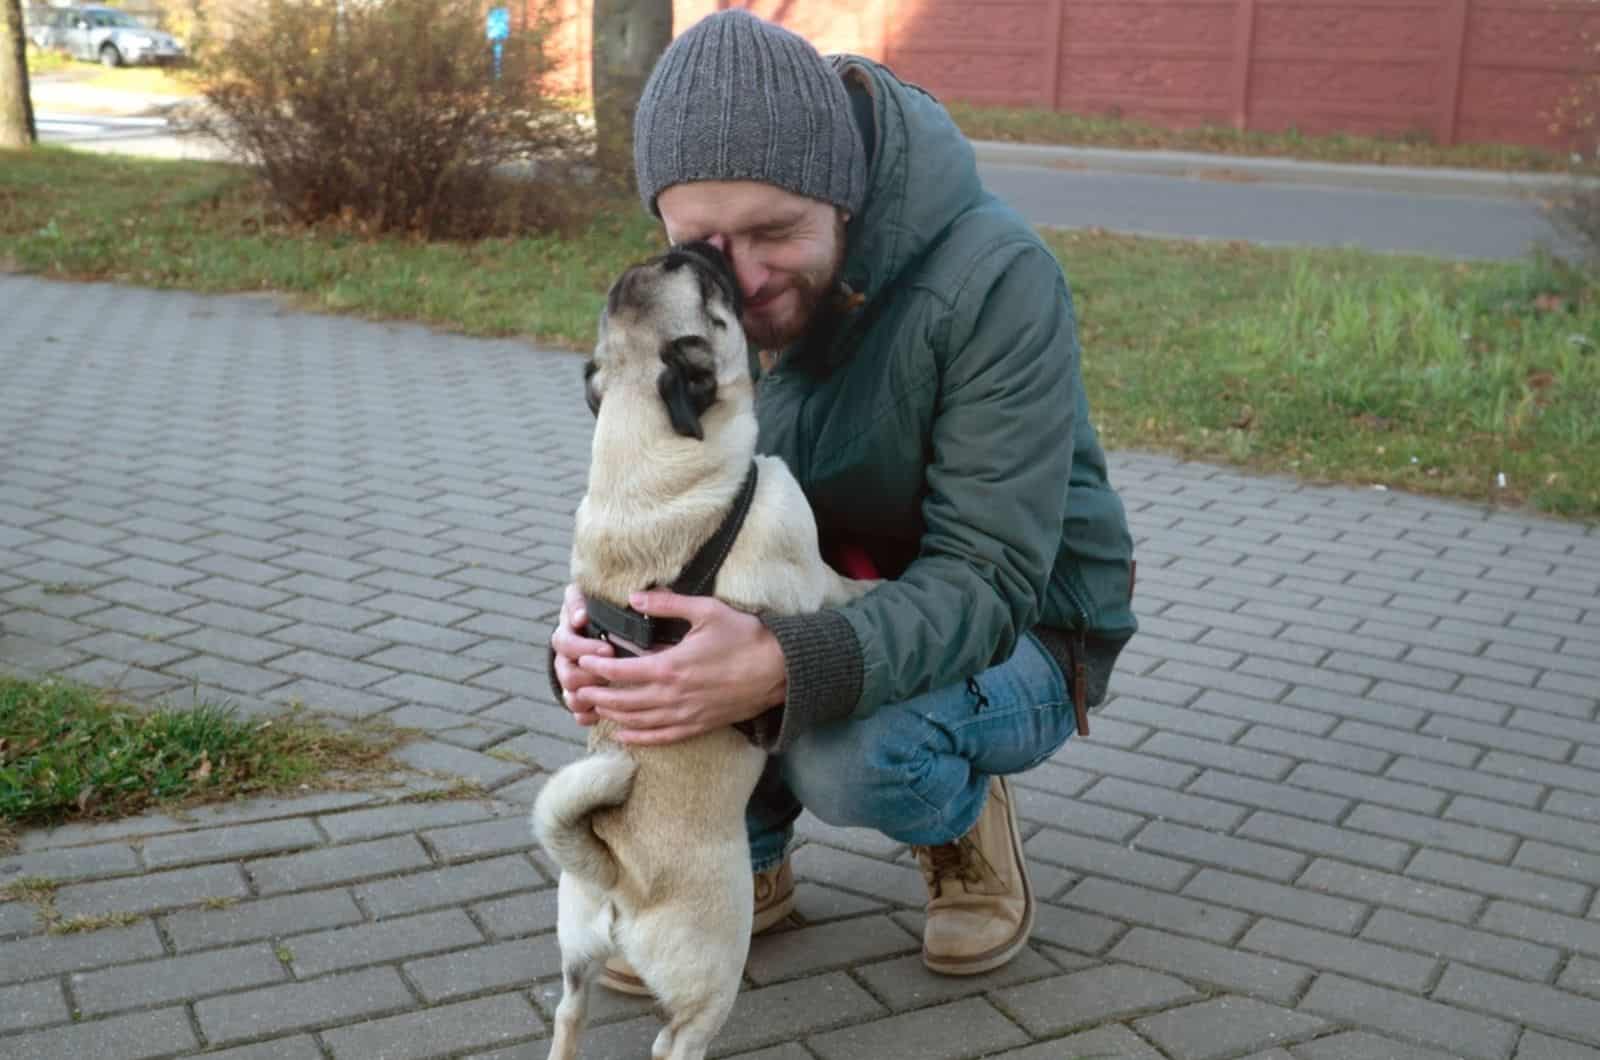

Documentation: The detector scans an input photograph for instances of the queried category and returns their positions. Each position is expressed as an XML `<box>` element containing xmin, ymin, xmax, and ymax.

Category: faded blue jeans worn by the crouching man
<box><xmin>744</xmin><ymin>634</ymin><xmax>1075</xmax><ymax>873</ymax></box>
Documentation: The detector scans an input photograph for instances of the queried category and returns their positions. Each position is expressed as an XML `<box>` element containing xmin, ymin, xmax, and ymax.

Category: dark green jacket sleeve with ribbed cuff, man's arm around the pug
<box><xmin>763</xmin><ymin>243</ymin><xmax>1082</xmax><ymax>749</ymax></box>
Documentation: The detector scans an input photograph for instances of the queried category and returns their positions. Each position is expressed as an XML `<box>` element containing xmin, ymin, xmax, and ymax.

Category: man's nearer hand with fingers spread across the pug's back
<box><xmin>569</xmin><ymin>591</ymin><xmax>787</xmax><ymax>743</ymax></box>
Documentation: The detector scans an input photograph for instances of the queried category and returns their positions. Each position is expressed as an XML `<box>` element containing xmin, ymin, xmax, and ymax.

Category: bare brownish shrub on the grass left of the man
<box><xmin>190</xmin><ymin>0</ymin><xmax>581</xmax><ymax>239</ymax></box>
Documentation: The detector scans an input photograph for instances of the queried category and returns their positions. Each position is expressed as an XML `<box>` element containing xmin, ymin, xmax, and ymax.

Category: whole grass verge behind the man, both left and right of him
<box><xmin>0</xmin><ymin>151</ymin><xmax>1600</xmax><ymax>519</ymax></box>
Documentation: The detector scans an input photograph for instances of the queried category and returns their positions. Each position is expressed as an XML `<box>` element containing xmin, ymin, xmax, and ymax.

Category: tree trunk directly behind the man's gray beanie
<box><xmin>590</xmin><ymin>0</ymin><xmax>672</xmax><ymax>186</ymax></box>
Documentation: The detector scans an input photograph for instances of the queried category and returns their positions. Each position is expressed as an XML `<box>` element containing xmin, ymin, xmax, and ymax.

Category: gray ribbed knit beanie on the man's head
<box><xmin>634</xmin><ymin>8</ymin><xmax>867</xmax><ymax>216</ymax></box>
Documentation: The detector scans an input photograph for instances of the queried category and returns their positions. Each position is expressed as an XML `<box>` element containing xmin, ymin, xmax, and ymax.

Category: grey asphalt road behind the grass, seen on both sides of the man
<box><xmin>37</xmin><ymin>112</ymin><xmax>1562</xmax><ymax>259</ymax></box>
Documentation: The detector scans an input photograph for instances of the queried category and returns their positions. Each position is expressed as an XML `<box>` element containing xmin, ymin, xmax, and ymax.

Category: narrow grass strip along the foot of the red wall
<box><xmin>947</xmin><ymin>102</ymin><xmax>1566</xmax><ymax>173</ymax></box>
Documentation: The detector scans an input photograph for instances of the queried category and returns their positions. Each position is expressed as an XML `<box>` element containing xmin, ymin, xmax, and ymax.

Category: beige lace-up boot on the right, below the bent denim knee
<box><xmin>915</xmin><ymin>777</ymin><xmax>1034</xmax><ymax>975</ymax></box>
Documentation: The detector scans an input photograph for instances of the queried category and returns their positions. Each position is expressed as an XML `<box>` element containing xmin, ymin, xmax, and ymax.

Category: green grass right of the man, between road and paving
<box><xmin>1050</xmin><ymin>232</ymin><xmax>1600</xmax><ymax>519</ymax></box>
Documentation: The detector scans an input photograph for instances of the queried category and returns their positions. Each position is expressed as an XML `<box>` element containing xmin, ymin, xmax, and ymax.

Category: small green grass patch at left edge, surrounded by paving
<box><xmin>0</xmin><ymin>676</ymin><xmax>402</xmax><ymax>829</ymax></box>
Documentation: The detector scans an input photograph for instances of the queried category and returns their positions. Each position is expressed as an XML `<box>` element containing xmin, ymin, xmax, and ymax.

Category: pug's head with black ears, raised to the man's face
<box><xmin>584</xmin><ymin>242</ymin><xmax>749</xmax><ymax>439</ymax></box>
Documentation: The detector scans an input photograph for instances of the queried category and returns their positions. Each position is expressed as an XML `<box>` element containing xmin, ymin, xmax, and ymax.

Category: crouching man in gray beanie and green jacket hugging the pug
<box><xmin>552</xmin><ymin>10</ymin><xmax>1136</xmax><ymax>990</ymax></box>
